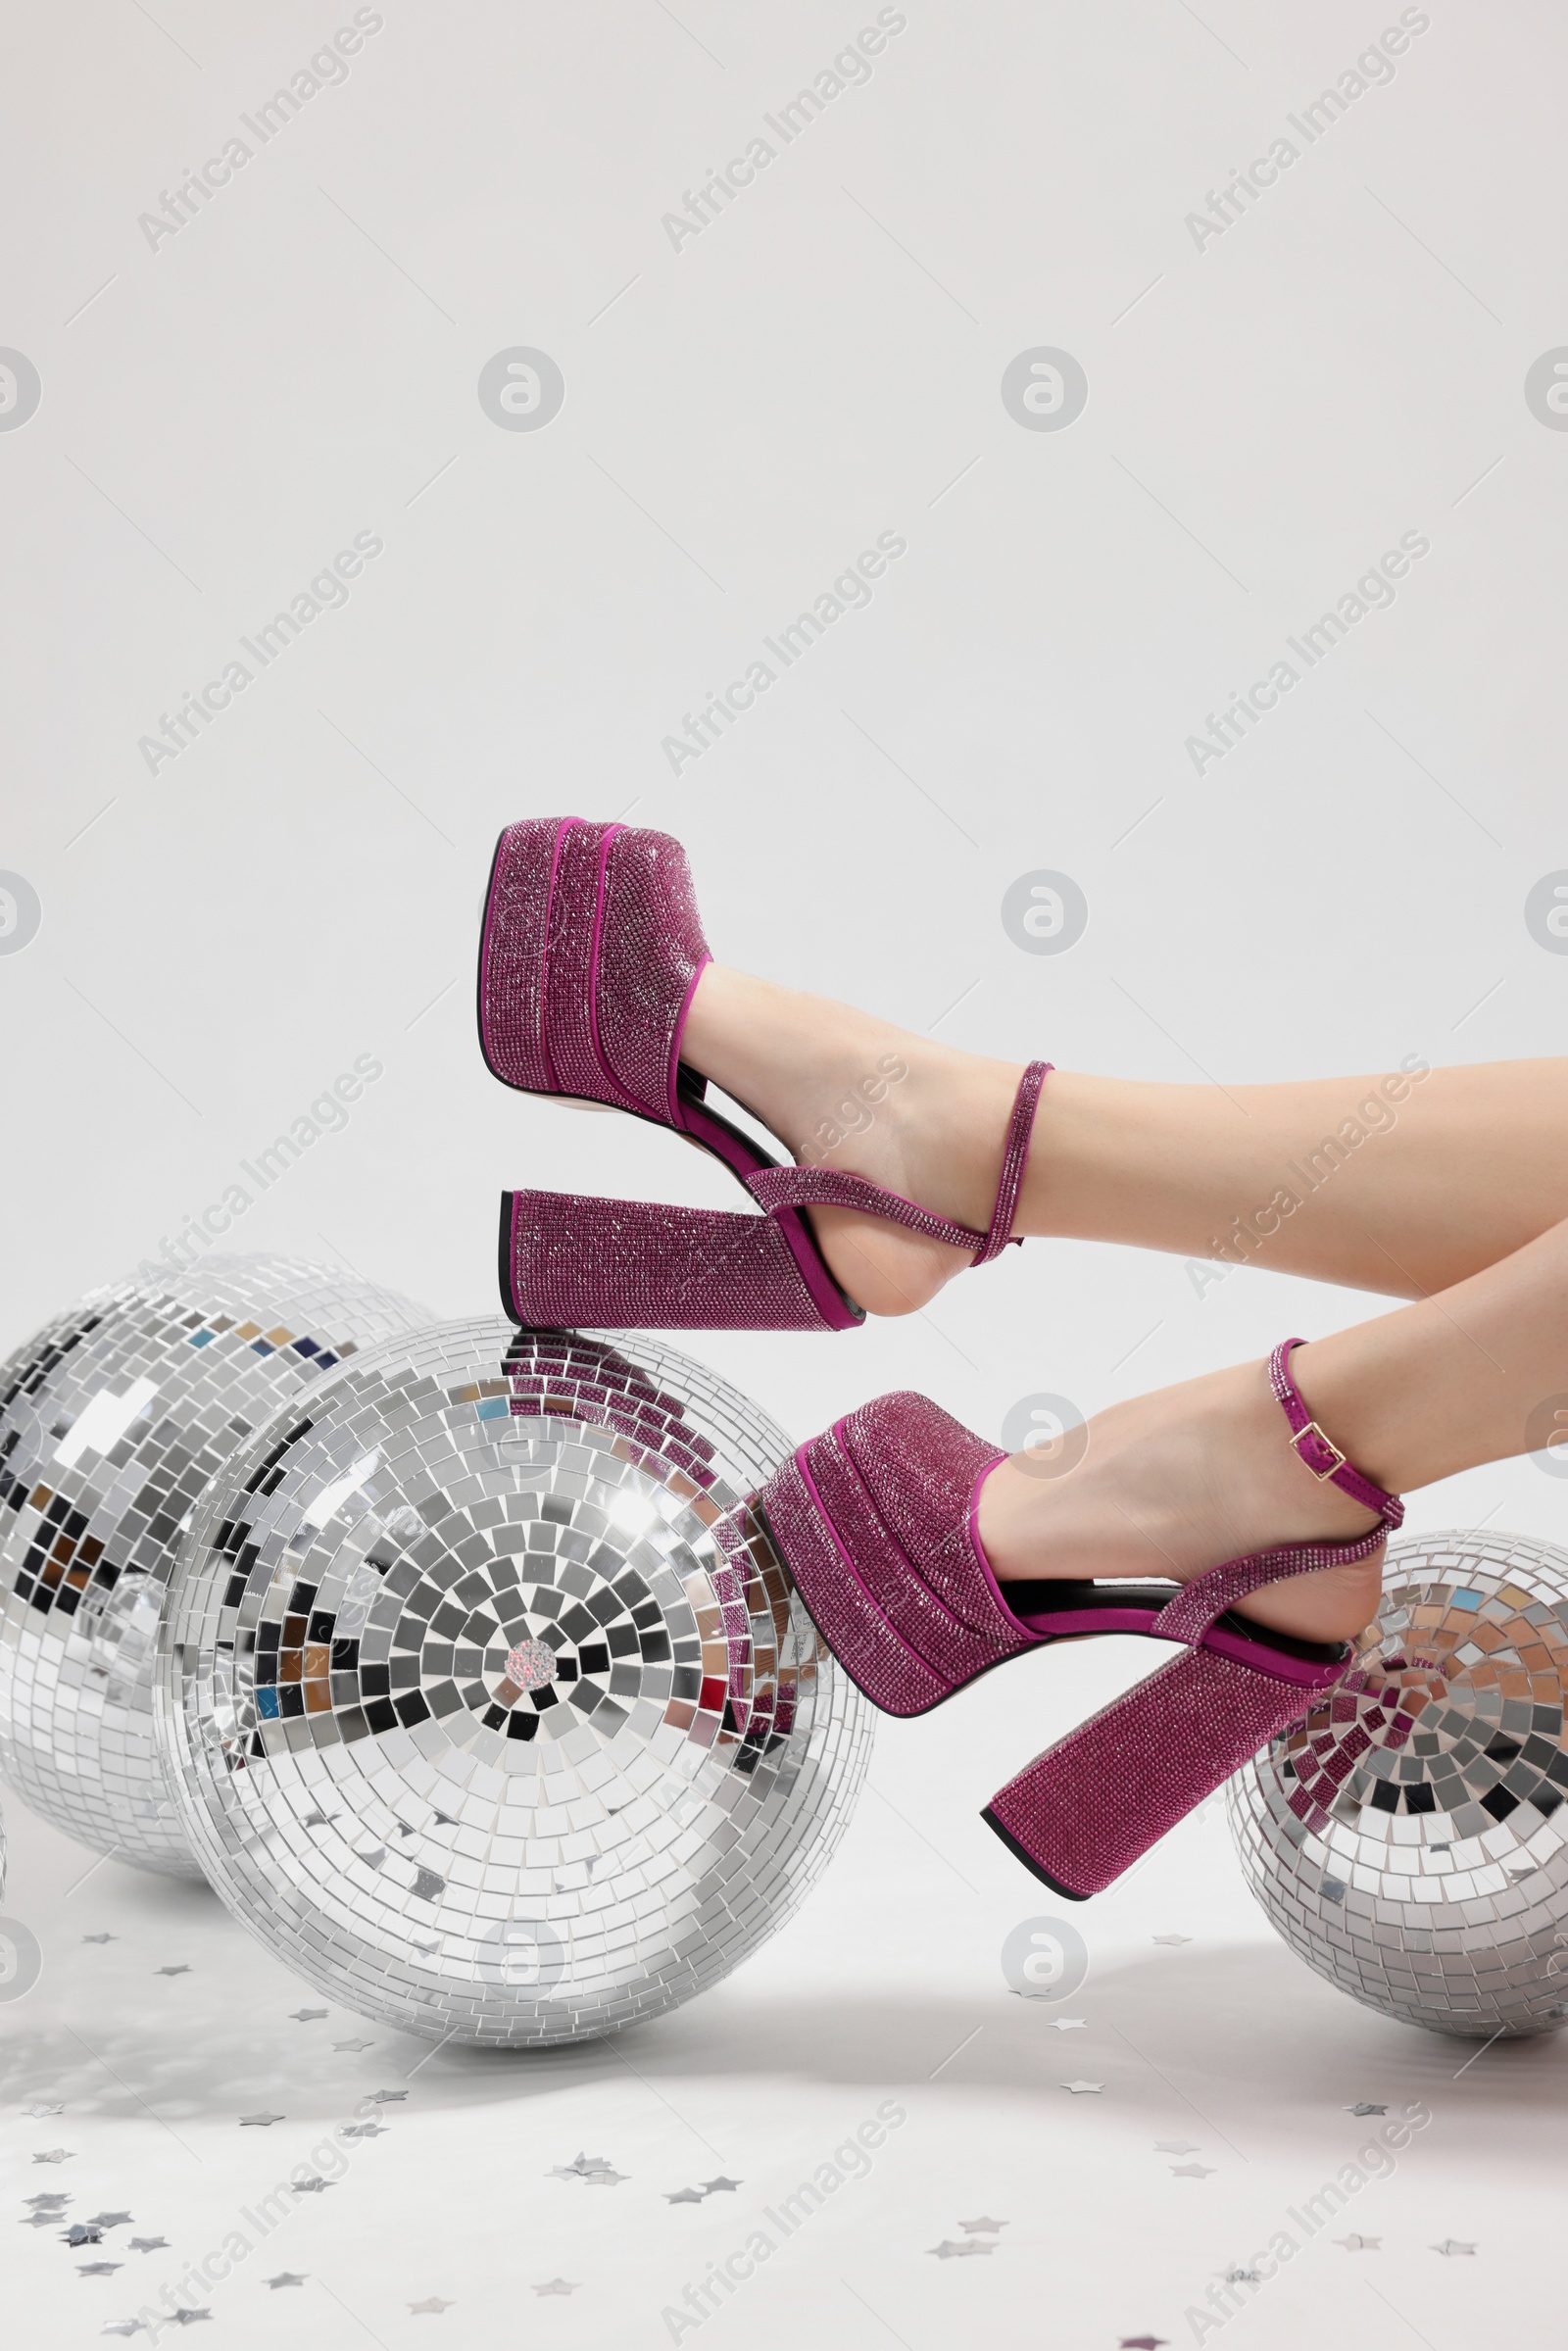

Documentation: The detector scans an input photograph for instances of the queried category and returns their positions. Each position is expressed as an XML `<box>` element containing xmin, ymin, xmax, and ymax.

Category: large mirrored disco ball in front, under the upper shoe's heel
<box><xmin>158</xmin><ymin>1319</ymin><xmax>870</xmax><ymax>2048</ymax></box>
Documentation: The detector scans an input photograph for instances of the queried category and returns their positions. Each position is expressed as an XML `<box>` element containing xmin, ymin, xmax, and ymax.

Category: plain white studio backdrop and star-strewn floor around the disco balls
<box><xmin>0</xmin><ymin>0</ymin><xmax>1568</xmax><ymax>2351</ymax></box>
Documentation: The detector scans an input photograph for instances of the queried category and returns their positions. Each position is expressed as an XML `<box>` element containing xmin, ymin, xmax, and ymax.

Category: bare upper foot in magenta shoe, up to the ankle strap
<box><xmin>682</xmin><ymin>964</ymin><xmax>1022</xmax><ymax>1314</ymax></box>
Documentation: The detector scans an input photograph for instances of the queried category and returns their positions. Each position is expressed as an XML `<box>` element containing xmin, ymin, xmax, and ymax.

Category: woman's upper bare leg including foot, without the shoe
<box><xmin>684</xmin><ymin>964</ymin><xmax>1568</xmax><ymax>1314</ymax></box>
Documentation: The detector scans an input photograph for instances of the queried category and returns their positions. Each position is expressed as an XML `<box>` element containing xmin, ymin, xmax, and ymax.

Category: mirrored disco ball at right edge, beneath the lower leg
<box><xmin>1230</xmin><ymin>1531</ymin><xmax>1568</xmax><ymax>2038</ymax></box>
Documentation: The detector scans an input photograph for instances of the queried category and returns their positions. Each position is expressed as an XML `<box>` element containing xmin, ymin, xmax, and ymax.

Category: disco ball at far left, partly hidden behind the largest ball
<box><xmin>0</xmin><ymin>1255</ymin><xmax>423</xmax><ymax>1876</ymax></box>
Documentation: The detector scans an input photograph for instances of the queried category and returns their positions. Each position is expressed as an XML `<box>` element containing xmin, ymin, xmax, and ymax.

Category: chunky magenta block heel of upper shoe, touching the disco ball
<box><xmin>501</xmin><ymin>1192</ymin><xmax>865</xmax><ymax>1331</ymax></box>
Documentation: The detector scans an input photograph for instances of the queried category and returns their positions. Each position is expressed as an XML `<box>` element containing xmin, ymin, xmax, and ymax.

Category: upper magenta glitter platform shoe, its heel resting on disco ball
<box><xmin>479</xmin><ymin>815</ymin><xmax>1049</xmax><ymax>1331</ymax></box>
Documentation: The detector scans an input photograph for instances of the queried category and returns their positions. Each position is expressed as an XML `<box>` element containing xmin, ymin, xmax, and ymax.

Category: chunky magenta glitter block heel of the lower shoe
<box><xmin>980</xmin><ymin>1643</ymin><xmax>1349</xmax><ymax>1902</ymax></box>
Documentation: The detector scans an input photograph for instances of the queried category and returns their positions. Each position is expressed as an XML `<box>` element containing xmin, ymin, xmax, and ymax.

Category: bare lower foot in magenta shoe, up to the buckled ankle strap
<box><xmin>978</xmin><ymin>1347</ymin><xmax>1382</xmax><ymax>1641</ymax></box>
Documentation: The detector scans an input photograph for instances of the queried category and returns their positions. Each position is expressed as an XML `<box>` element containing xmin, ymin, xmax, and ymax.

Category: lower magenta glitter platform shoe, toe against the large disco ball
<box><xmin>757</xmin><ymin>1338</ymin><xmax>1403</xmax><ymax>1899</ymax></box>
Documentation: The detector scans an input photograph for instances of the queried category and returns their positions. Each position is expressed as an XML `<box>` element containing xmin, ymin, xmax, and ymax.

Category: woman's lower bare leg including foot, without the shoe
<box><xmin>980</xmin><ymin>1220</ymin><xmax>1568</xmax><ymax>1641</ymax></box>
